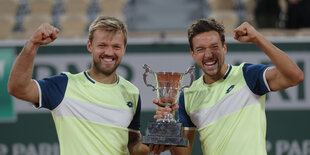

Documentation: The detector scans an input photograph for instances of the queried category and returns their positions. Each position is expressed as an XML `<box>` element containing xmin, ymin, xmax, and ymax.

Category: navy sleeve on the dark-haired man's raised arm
<box><xmin>242</xmin><ymin>63</ymin><xmax>270</xmax><ymax>95</ymax></box>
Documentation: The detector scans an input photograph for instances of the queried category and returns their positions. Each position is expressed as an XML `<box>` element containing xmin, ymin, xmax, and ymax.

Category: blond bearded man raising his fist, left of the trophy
<box><xmin>8</xmin><ymin>16</ymin><xmax>149</xmax><ymax>155</ymax></box>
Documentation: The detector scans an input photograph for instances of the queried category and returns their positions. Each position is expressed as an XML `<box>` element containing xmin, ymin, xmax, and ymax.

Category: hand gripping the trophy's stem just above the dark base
<box><xmin>153</xmin><ymin>99</ymin><xmax>179</xmax><ymax>119</ymax></box>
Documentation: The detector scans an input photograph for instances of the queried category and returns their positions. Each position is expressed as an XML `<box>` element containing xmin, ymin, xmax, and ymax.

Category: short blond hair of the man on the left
<box><xmin>88</xmin><ymin>16</ymin><xmax>127</xmax><ymax>46</ymax></box>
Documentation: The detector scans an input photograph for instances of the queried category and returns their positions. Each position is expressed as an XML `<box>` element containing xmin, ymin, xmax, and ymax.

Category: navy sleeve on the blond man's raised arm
<box><xmin>36</xmin><ymin>73</ymin><xmax>68</xmax><ymax>110</ymax></box>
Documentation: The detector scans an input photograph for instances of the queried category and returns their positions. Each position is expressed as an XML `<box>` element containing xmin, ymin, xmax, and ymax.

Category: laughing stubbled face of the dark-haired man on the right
<box><xmin>191</xmin><ymin>31</ymin><xmax>227</xmax><ymax>81</ymax></box>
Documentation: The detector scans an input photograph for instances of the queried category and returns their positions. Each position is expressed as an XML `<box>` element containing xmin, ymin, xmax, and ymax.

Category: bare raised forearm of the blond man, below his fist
<box><xmin>8</xmin><ymin>41</ymin><xmax>39</xmax><ymax>94</ymax></box>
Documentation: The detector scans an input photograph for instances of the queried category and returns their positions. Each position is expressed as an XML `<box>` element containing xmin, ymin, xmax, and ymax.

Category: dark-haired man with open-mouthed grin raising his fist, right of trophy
<box><xmin>153</xmin><ymin>19</ymin><xmax>304</xmax><ymax>155</ymax></box>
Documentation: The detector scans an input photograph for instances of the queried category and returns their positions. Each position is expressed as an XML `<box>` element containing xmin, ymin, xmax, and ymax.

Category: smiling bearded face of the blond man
<box><xmin>87</xmin><ymin>29</ymin><xmax>125</xmax><ymax>76</ymax></box>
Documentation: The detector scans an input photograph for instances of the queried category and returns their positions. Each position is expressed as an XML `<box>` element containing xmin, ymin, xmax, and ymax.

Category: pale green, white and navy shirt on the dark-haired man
<box><xmin>178</xmin><ymin>63</ymin><xmax>270</xmax><ymax>155</ymax></box>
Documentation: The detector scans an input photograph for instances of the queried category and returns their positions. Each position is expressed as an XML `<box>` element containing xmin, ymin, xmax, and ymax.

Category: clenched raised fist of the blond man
<box><xmin>29</xmin><ymin>23</ymin><xmax>59</xmax><ymax>46</ymax></box>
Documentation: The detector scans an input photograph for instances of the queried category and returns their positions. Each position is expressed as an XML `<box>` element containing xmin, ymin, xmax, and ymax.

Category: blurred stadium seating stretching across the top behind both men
<box><xmin>0</xmin><ymin>0</ymin><xmax>310</xmax><ymax>40</ymax></box>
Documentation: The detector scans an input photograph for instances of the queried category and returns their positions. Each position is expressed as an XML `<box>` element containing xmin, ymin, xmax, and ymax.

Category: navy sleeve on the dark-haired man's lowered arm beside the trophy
<box><xmin>178</xmin><ymin>92</ymin><xmax>196</xmax><ymax>127</ymax></box>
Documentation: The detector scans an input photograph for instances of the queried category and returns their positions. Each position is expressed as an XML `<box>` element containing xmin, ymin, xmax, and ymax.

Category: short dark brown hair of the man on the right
<box><xmin>187</xmin><ymin>18</ymin><xmax>225</xmax><ymax>51</ymax></box>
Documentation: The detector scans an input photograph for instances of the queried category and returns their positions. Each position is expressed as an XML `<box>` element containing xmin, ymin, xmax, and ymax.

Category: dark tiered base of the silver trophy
<box><xmin>142</xmin><ymin>121</ymin><xmax>188</xmax><ymax>147</ymax></box>
